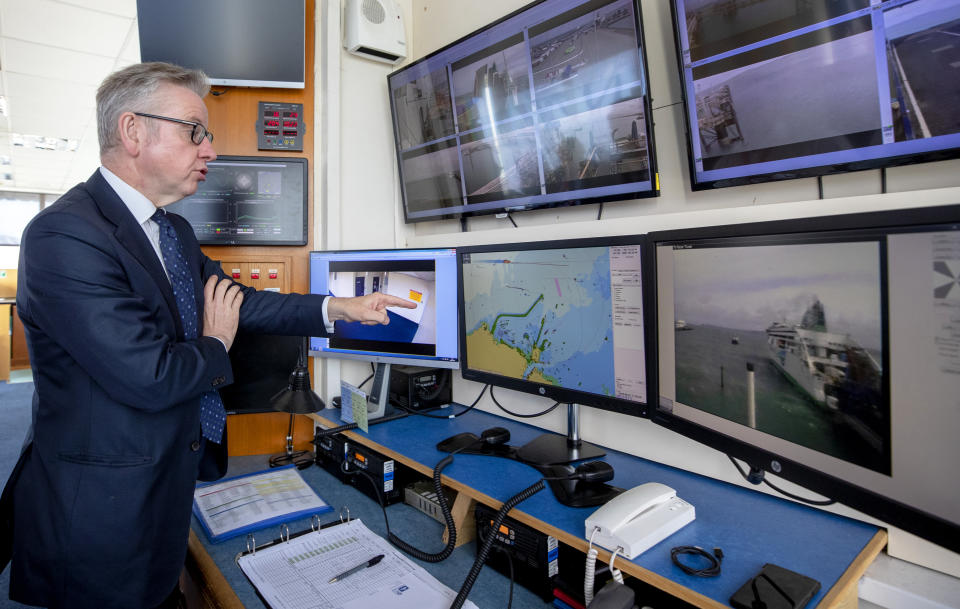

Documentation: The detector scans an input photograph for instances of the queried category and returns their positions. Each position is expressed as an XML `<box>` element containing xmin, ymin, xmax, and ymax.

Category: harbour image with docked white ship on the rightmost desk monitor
<box><xmin>673</xmin><ymin>241</ymin><xmax>890</xmax><ymax>473</ymax></box>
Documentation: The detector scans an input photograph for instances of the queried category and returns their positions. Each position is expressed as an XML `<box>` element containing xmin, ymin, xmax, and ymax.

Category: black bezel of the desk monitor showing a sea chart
<box><xmin>457</xmin><ymin>235</ymin><xmax>657</xmax><ymax>418</ymax></box>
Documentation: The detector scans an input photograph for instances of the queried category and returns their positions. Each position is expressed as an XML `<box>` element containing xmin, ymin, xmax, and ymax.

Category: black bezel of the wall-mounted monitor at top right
<box><xmin>670</xmin><ymin>0</ymin><xmax>960</xmax><ymax>191</ymax></box>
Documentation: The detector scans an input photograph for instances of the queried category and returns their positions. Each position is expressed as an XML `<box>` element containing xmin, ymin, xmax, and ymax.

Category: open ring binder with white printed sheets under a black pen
<box><xmin>237</xmin><ymin>520</ymin><xmax>477</xmax><ymax>609</ymax></box>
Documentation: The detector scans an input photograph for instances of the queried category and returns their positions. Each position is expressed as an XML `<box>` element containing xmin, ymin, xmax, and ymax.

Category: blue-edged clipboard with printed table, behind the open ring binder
<box><xmin>193</xmin><ymin>464</ymin><xmax>333</xmax><ymax>542</ymax></box>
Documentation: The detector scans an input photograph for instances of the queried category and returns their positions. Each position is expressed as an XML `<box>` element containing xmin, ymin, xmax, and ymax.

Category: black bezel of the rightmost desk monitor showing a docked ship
<box><xmin>646</xmin><ymin>204</ymin><xmax>960</xmax><ymax>552</ymax></box>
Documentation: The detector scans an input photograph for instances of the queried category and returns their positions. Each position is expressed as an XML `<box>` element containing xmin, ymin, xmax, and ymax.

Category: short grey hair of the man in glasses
<box><xmin>97</xmin><ymin>61</ymin><xmax>210</xmax><ymax>154</ymax></box>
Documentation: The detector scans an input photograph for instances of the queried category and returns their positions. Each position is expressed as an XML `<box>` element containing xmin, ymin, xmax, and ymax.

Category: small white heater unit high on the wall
<box><xmin>343</xmin><ymin>0</ymin><xmax>407</xmax><ymax>64</ymax></box>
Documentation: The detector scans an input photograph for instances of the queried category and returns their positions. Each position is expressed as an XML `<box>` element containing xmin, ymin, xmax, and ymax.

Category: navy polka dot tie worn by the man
<box><xmin>151</xmin><ymin>209</ymin><xmax>227</xmax><ymax>444</ymax></box>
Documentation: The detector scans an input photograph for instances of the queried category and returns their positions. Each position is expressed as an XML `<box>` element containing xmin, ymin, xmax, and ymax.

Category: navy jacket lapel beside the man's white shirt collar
<box><xmin>85</xmin><ymin>169</ymin><xmax>183</xmax><ymax>338</ymax></box>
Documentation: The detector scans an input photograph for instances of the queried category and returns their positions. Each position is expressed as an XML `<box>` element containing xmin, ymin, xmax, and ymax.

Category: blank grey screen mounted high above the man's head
<box><xmin>137</xmin><ymin>0</ymin><xmax>304</xmax><ymax>89</ymax></box>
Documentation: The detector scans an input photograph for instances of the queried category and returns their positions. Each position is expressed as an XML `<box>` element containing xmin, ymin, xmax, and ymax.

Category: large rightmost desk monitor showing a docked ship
<box><xmin>648</xmin><ymin>206</ymin><xmax>960</xmax><ymax>552</ymax></box>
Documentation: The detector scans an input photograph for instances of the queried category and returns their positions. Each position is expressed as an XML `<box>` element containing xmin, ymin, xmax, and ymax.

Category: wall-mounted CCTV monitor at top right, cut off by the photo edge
<box><xmin>672</xmin><ymin>0</ymin><xmax>960</xmax><ymax>190</ymax></box>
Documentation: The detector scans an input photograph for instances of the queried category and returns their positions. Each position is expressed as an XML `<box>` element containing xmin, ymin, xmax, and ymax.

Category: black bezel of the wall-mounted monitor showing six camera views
<box><xmin>387</xmin><ymin>0</ymin><xmax>660</xmax><ymax>224</ymax></box>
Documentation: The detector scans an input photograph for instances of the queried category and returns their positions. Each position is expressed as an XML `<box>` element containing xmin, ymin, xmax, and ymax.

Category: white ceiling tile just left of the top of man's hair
<box><xmin>0</xmin><ymin>38</ymin><xmax>114</xmax><ymax>87</ymax></box>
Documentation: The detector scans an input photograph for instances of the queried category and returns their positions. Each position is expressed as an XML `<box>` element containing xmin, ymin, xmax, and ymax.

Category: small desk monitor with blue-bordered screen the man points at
<box><xmin>310</xmin><ymin>248</ymin><xmax>459</xmax><ymax>368</ymax></box>
